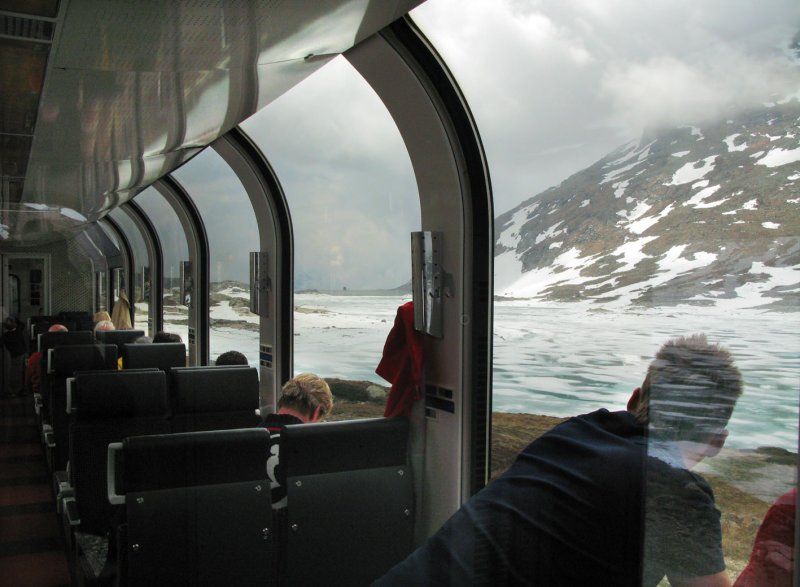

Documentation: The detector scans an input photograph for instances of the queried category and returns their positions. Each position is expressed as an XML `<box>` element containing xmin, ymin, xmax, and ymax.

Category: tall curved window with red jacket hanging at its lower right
<box><xmin>242</xmin><ymin>57</ymin><xmax>420</xmax><ymax>416</ymax></box>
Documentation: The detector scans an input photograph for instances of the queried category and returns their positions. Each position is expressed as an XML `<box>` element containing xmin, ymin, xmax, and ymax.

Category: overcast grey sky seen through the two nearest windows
<box><xmin>178</xmin><ymin>0</ymin><xmax>800</xmax><ymax>289</ymax></box>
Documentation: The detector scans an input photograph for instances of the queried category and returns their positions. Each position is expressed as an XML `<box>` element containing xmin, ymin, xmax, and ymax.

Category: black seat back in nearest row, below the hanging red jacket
<box><xmin>279</xmin><ymin>418</ymin><xmax>414</xmax><ymax>585</ymax></box>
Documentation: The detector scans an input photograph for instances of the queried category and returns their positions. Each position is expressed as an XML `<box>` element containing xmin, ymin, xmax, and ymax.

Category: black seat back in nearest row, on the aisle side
<box><xmin>108</xmin><ymin>428</ymin><xmax>276</xmax><ymax>587</ymax></box>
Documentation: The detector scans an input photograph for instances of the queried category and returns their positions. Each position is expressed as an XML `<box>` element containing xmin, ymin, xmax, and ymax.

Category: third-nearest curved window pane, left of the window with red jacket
<box><xmin>175</xmin><ymin>149</ymin><xmax>259</xmax><ymax>367</ymax></box>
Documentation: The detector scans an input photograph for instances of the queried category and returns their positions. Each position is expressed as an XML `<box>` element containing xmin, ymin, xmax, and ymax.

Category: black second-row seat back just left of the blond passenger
<box><xmin>170</xmin><ymin>365</ymin><xmax>260</xmax><ymax>432</ymax></box>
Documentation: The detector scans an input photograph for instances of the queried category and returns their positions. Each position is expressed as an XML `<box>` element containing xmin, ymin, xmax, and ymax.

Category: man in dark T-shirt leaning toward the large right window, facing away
<box><xmin>376</xmin><ymin>335</ymin><xmax>742</xmax><ymax>587</ymax></box>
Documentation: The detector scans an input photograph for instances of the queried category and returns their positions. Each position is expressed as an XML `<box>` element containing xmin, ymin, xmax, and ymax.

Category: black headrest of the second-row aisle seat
<box><xmin>71</xmin><ymin>371</ymin><xmax>167</xmax><ymax>420</ymax></box>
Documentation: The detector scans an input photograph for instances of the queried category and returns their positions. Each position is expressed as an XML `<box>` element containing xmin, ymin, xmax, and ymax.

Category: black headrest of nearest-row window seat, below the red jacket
<box><xmin>281</xmin><ymin>418</ymin><xmax>408</xmax><ymax>477</ymax></box>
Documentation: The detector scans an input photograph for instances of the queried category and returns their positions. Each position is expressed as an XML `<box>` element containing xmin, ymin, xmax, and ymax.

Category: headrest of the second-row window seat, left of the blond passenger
<box><xmin>170</xmin><ymin>365</ymin><xmax>260</xmax><ymax>413</ymax></box>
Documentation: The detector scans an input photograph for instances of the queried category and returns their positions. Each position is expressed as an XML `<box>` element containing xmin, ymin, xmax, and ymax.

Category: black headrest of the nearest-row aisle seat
<box><xmin>116</xmin><ymin>428</ymin><xmax>269</xmax><ymax>500</ymax></box>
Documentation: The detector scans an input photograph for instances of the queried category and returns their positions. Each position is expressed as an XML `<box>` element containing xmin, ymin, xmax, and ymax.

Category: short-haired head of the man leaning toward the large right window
<box><xmin>642</xmin><ymin>334</ymin><xmax>742</xmax><ymax>442</ymax></box>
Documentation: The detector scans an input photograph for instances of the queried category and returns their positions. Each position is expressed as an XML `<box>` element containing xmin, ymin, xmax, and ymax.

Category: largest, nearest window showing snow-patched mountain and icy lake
<box><xmin>412</xmin><ymin>0</ymin><xmax>800</xmax><ymax>580</ymax></box>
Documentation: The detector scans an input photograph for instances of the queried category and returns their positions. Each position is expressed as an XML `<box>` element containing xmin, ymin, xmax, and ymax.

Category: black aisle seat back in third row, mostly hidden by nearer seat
<box><xmin>48</xmin><ymin>344</ymin><xmax>117</xmax><ymax>471</ymax></box>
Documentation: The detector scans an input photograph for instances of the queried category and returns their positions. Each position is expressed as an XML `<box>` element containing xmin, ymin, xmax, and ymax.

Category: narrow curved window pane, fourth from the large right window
<box><xmin>136</xmin><ymin>188</ymin><xmax>189</xmax><ymax>346</ymax></box>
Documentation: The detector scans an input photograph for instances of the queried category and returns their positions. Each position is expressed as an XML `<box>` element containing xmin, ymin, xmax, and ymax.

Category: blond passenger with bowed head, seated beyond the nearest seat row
<box><xmin>263</xmin><ymin>373</ymin><xmax>333</xmax><ymax>509</ymax></box>
